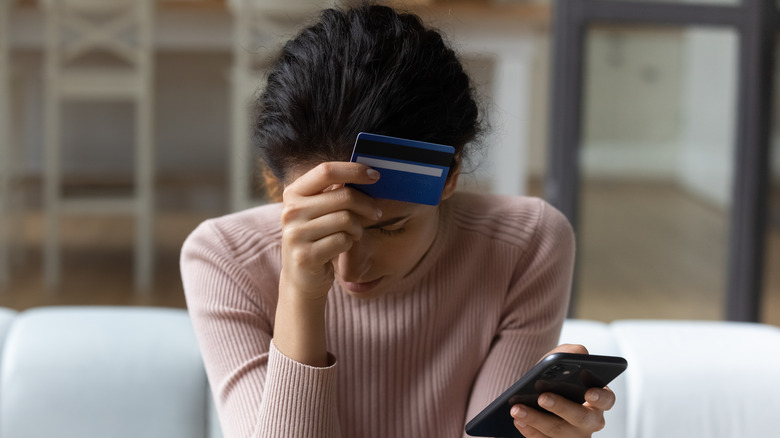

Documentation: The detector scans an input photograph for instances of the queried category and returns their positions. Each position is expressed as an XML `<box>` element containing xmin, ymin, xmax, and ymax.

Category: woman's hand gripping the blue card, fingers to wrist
<box><xmin>280</xmin><ymin>162</ymin><xmax>382</xmax><ymax>301</ymax></box>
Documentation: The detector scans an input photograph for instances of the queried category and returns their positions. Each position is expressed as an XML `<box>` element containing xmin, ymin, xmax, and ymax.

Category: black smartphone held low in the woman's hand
<box><xmin>466</xmin><ymin>353</ymin><xmax>628</xmax><ymax>438</ymax></box>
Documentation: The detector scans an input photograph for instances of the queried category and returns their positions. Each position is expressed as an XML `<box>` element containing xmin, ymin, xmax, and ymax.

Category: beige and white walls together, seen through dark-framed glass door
<box><xmin>581</xmin><ymin>28</ymin><xmax>748</xmax><ymax>208</ymax></box>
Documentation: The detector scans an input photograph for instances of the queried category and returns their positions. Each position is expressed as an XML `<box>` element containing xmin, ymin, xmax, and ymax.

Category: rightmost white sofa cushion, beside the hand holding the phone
<box><xmin>611</xmin><ymin>321</ymin><xmax>780</xmax><ymax>438</ymax></box>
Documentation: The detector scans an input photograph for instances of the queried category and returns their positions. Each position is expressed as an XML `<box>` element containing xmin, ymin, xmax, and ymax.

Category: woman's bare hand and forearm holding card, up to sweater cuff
<box><xmin>274</xmin><ymin>162</ymin><xmax>382</xmax><ymax>367</ymax></box>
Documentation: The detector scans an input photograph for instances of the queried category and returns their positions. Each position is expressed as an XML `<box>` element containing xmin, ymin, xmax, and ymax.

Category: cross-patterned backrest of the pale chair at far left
<box><xmin>44</xmin><ymin>0</ymin><xmax>154</xmax><ymax>77</ymax></box>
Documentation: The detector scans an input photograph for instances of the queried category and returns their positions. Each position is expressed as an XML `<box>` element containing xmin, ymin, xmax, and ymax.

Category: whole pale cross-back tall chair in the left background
<box><xmin>43</xmin><ymin>0</ymin><xmax>154</xmax><ymax>290</ymax></box>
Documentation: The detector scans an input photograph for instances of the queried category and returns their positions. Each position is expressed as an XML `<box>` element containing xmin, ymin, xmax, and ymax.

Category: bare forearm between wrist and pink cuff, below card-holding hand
<box><xmin>274</xmin><ymin>276</ymin><xmax>330</xmax><ymax>367</ymax></box>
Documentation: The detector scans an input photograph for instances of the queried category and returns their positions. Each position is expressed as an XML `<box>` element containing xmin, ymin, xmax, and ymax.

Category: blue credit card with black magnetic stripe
<box><xmin>347</xmin><ymin>132</ymin><xmax>455</xmax><ymax>205</ymax></box>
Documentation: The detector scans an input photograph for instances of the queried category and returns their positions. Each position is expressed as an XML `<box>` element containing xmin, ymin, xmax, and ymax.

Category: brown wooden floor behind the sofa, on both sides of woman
<box><xmin>0</xmin><ymin>183</ymin><xmax>780</xmax><ymax>325</ymax></box>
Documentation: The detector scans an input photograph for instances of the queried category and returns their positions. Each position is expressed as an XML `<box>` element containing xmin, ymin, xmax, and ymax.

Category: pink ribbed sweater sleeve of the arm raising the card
<box><xmin>181</xmin><ymin>221</ymin><xmax>339</xmax><ymax>438</ymax></box>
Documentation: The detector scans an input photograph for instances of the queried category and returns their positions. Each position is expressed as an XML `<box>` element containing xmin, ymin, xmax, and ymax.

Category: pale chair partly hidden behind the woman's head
<box><xmin>228</xmin><ymin>0</ymin><xmax>334</xmax><ymax>211</ymax></box>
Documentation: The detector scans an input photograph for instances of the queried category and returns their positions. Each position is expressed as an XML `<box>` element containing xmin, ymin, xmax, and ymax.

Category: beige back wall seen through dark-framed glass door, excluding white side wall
<box><xmin>581</xmin><ymin>29</ymin><xmax>683</xmax><ymax>179</ymax></box>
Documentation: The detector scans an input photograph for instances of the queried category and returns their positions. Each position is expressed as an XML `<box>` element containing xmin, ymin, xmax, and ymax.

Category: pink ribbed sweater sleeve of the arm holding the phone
<box><xmin>464</xmin><ymin>200</ymin><xmax>575</xmax><ymax>436</ymax></box>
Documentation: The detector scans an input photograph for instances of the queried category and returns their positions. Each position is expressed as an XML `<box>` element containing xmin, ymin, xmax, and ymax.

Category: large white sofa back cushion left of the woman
<box><xmin>0</xmin><ymin>307</ymin><xmax>208</xmax><ymax>438</ymax></box>
